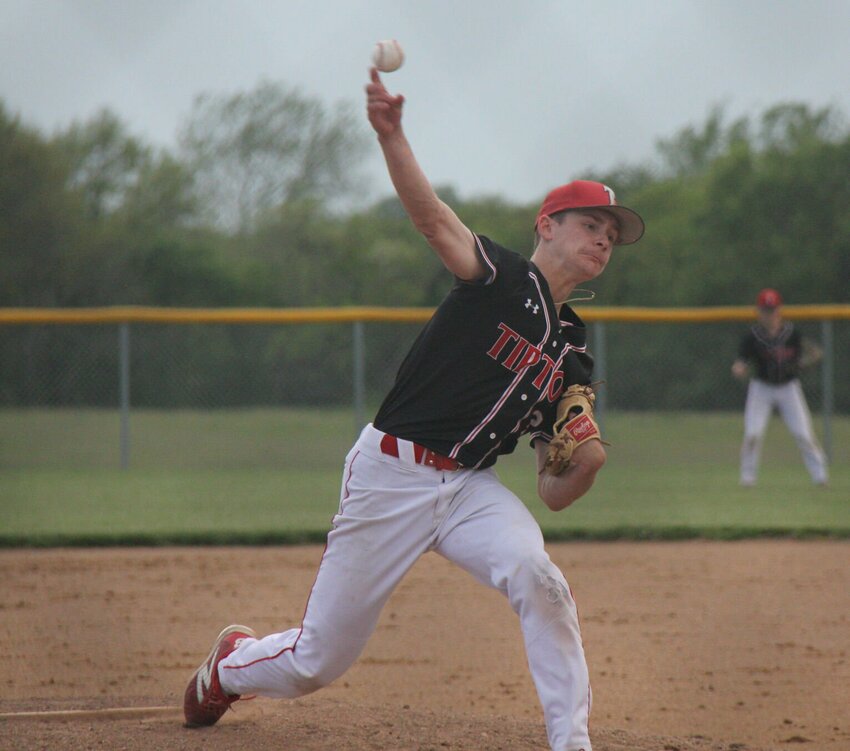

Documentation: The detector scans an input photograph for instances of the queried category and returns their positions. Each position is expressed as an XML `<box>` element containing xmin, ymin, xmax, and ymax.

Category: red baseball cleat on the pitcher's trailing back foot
<box><xmin>183</xmin><ymin>626</ymin><xmax>257</xmax><ymax>728</ymax></box>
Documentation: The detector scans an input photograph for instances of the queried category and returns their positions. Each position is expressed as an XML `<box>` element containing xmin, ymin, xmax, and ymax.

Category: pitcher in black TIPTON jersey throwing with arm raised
<box><xmin>184</xmin><ymin>69</ymin><xmax>644</xmax><ymax>751</ymax></box>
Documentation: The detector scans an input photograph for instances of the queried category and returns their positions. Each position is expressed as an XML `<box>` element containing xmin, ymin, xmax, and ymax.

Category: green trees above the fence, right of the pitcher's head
<box><xmin>595</xmin><ymin>104</ymin><xmax>850</xmax><ymax>306</ymax></box>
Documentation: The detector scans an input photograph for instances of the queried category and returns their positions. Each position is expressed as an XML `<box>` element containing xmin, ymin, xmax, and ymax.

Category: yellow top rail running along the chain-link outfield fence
<box><xmin>0</xmin><ymin>304</ymin><xmax>850</xmax><ymax>325</ymax></box>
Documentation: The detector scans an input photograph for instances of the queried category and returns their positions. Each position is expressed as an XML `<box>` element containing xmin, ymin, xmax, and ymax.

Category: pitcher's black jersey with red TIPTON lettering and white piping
<box><xmin>374</xmin><ymin>235</ymin><xmax>593</xmax><ymax>468</ymax></box>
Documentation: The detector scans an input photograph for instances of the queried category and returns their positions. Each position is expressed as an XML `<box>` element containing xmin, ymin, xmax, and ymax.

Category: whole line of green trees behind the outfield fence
<box><xmin>0</xmin><ymin>82</ymin><xmax>850</xmax><ymax>409</ymax></box>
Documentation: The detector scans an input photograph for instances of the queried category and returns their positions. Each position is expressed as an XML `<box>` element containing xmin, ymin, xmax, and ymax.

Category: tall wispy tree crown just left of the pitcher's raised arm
<box><xmin>180</xmin><ymin>82</ymin><xmax>366</xmax><ymax>233</ymax></box>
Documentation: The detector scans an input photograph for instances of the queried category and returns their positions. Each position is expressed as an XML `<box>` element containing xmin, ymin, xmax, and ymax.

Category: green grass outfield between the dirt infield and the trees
<box><xmin>0</xmin><ymin>409</ymin><xmax>850</xmax><ymax>546</ymax></box>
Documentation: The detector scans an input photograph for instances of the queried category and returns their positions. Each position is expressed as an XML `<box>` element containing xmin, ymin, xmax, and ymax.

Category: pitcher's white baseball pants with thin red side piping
<box><xmin>219</xmin><ymin>425</ymin><xmax>591</xmax><ymax>751</ymax></box>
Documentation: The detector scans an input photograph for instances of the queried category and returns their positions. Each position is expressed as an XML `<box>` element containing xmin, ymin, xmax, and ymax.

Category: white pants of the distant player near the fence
<box><xmin>741</xmin><ymin>378</ymin><xmax>829</xmax><ymax>485</ymax></box>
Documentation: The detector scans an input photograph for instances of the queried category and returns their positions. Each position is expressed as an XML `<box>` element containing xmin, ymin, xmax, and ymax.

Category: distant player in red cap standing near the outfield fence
<box><xmin>732</xmin><ymin>288</ymin><xmax>829</xmax><ymax>487</ymax></box>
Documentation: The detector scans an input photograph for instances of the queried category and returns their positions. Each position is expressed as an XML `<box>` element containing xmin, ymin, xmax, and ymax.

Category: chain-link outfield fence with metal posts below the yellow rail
<box><xmin>0</xmin><ymin>309</ymin><xmax>850</xmax><ymax>469</ymax></box>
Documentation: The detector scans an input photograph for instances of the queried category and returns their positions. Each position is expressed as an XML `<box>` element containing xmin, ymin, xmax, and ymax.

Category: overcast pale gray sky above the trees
<box><xmin>0</xmin><ymin>0</ymin><xmax>850</xmax><ymax>202</ymax></box>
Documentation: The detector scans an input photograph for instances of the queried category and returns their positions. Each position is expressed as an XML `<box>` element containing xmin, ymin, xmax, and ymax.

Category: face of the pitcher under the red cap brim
<box><xmin>555</xmin><ymin>209</ymin><xmax>619</xmax><ymax>281</ymax></box>
